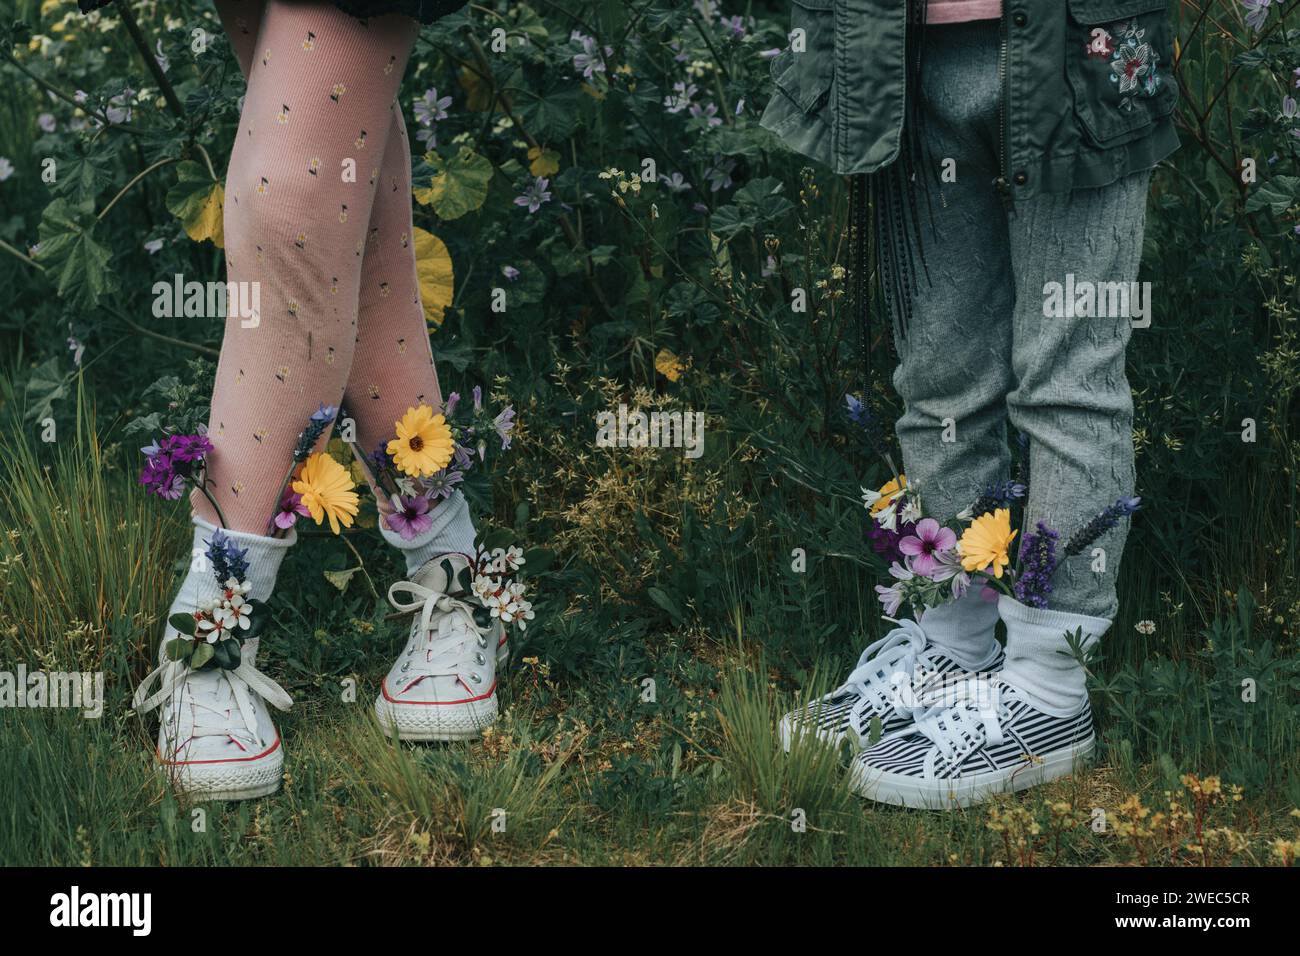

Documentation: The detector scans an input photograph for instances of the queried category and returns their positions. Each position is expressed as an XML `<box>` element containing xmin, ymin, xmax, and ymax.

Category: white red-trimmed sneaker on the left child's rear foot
<box><xmin>374</xmin><ymin>554</ymin><xmax>510</xmax><ymax>740</ymax></box>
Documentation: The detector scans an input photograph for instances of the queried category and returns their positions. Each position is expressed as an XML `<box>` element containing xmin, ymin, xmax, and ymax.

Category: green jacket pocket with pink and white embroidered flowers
<box><xmin>1065</xmin><ymin>0</ymin><xmax>1178</xmax><ymax>147</ymax></box>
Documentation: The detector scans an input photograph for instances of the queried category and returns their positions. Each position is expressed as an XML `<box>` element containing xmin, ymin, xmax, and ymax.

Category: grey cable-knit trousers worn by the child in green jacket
<box><xmin>893</xmin><ymin>21</ymin><xmax>1151</xmax><ymax>618</ymax></box>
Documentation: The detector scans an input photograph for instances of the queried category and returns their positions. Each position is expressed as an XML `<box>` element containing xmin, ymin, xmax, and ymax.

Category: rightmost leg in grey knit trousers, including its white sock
<box><xmin>1002</xmin><ymin>172</ymin><xmax>1151</xmax><ymax>713</ymax></box>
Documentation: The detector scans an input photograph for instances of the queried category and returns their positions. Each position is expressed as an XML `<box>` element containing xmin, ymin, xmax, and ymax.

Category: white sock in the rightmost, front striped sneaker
<box><xmin>997</xmin><ymin>594</ymin><xmax>1110</xmax><ymax>717</ymax></box>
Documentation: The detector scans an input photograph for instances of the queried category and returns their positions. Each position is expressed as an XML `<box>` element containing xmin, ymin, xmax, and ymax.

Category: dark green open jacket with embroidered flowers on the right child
<box><xmin>762</xmin><ymin>0</ymin><xmax>1178</xmax><ymax>200</ymax></box>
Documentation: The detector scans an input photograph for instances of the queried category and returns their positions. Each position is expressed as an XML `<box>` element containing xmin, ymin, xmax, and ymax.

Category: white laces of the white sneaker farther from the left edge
<box><xmin>389</xmin><ymin>581</ymin><xmax>489</xmax><ymax>693</ymax></box>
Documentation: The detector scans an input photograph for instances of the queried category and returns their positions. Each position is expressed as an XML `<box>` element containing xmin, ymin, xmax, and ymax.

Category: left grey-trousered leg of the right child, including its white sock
<box><xmin>893</xmin><ymin>23</ymin><xmax>1013</xmax><ymax>666</ymax></box>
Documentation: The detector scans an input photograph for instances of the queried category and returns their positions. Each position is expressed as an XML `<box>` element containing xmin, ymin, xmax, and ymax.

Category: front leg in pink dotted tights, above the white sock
<box><xmin>194</xmin><ymin>0</ymin><xmax>417</xmax><ymax>535</ymax></box>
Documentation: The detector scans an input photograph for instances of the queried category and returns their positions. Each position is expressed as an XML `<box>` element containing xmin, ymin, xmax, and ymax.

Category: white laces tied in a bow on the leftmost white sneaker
<box><xmin>131</xmin><ymin>657</ymin><xmax>294</xmax><ymax>756</ymax></box>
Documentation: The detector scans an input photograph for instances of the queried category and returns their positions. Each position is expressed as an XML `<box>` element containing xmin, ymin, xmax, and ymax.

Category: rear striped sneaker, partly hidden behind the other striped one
<box><xmin>781</xmin><ymin>618</ymin><xmax>1002</xmax><ymax>752</ymax></box>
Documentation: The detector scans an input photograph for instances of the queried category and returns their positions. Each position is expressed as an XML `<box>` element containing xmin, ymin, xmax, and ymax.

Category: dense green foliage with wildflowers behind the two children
<box><xmin>0</xmin><ymin>0</ymin><xmax>1300</xmax><ymax>862</ymax></box>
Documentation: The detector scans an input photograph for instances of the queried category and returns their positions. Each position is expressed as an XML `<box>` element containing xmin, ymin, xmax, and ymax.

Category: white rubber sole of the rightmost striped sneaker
<box><xmin>849</xmin><ymin>735</ymin><xmax>1096</xmax><ymax>810</ymax></box>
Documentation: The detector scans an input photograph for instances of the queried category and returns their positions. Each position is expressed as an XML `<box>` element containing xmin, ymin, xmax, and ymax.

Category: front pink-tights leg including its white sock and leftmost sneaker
<box><xmin>148</xmin><ymin>0</ymin><xmax>416</xmax><ymax>799</ymax></box>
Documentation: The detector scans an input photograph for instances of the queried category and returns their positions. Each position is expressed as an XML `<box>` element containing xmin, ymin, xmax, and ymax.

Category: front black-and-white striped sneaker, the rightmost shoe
<box><xmin>850</xmin><ymin>679</ymin><xmax>1095</xmax><ymax>809</ymax></box>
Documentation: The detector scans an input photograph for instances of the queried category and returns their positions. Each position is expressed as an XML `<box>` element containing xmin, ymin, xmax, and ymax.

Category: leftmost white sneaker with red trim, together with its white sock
<box><xmin>133</xmin><ymin>520</ymin><xmax>296</xmax><ymax>800</ymax></box>
